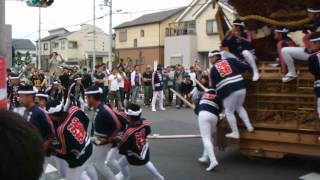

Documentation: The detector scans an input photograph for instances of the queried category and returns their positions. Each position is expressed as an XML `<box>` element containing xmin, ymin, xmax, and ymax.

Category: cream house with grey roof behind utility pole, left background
<box><xmin>37</xmin><ymin>24</ymin><xmax>111</xmax><ymax>70</ymax></box>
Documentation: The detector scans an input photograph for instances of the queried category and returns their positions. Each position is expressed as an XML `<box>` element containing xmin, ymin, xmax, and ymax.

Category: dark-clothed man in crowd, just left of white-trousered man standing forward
<box><xmin>142</xmin><ymin>65</ymin><xmax>152</xmax><ymax>106</ymax></box>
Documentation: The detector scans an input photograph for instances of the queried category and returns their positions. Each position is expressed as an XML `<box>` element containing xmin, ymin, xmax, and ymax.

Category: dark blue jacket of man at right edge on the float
<box><xmin>308</xmin><ymin>52</ymin><xmax>320</xmax><ymax>97</ymax></box>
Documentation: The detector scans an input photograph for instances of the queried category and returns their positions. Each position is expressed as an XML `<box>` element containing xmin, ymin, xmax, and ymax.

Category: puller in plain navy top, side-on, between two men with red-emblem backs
<box><xmin>85</xmin><ymin>86</ymin><xmax>122</xmax><ymax>179</ymax></box>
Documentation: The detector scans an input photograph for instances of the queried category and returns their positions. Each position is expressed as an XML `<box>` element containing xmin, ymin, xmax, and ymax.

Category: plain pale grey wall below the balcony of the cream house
<box><xmin>164</xmin><ymin>35</ymin><xmax>199</xmax><ymax>68</ymax></box>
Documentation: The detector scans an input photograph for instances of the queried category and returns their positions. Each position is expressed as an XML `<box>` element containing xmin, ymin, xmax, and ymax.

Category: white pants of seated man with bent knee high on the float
<box><xmin>281</xmin><ymin>47</ymin><xmax>310</xmax><ymax>76</ymax></box>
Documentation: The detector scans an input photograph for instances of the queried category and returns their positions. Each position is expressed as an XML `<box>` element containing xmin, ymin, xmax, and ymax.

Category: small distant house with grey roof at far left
<box><xmin>12</xmin><ymin>39</ymin><xmax>37</xmax><ymax>64</ymax></box>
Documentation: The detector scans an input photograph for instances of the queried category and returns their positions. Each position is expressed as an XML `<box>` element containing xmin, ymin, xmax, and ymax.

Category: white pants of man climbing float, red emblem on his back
<box><xmin>223</xmin><ymin>89</ymin><xmax>252</xmax><ymax>134</ymax></box>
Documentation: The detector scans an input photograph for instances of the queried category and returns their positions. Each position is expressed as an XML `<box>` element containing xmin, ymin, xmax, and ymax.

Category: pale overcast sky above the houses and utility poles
<box><xmin>6</xmin><ymin>0</ymin><xmax>192</xmax><ymax>40</ymax></box>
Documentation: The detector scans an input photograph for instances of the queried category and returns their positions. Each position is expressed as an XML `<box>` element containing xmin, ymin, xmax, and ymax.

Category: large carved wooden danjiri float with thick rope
<box><xmin>217</xmin><ymin>0</ymin><xmax>320</xmax><ymax>159</ymax></box>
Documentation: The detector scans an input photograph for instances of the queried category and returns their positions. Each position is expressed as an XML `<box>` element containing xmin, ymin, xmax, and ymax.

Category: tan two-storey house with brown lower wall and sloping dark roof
<box><xmin>114</xmin><ymin>7</ymin><xmax>185</xmax><ymax>70</ymax></box>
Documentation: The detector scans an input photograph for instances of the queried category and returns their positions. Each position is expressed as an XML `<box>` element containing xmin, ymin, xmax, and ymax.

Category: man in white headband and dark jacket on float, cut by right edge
<box><xmin>308</xmin><ymin>32</ymin><xmax>320</xmax><ymax>119</ymax></box>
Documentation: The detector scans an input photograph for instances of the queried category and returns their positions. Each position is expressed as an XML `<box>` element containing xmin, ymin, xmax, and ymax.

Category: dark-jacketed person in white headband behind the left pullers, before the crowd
<box><xmin>65</xmin><ymin>75</ymin><xmax>84</xmax><ymax>110</ymax></box>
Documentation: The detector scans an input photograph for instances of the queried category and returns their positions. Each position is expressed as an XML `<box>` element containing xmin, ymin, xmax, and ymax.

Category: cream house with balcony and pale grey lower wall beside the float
<box><xmin>165</xmin><ymin>0</ymin><xmax>221</xmax><ymax>69</ymax></box>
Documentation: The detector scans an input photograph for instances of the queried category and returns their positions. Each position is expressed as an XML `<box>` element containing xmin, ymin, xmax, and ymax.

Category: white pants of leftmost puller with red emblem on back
<box><xmin>56</xmin><ymin>158</ymin><xmax>91</xmax><ymax>180</ymax></box>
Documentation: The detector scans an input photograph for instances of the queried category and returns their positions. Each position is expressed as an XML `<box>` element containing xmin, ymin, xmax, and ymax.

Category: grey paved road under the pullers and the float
<box><xmin>45</xmin><ymin>106</ymin><xmax>320</xmax><ymax>180</ymax></box>
